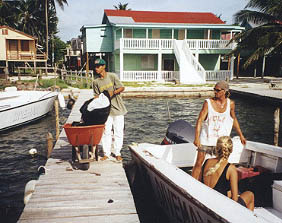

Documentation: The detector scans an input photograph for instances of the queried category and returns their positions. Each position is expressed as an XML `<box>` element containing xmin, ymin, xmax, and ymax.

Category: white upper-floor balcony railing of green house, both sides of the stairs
<box><xmin>115</xmin><ymin>38</ymin><xmax>234</xmax><ymax>50</ymax></box>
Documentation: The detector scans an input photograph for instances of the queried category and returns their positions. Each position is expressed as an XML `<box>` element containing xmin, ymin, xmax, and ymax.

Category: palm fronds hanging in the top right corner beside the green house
<box><xmin>232</xmin><ymin>0</ymin><xmax>282</xmax><ymax>67</ymax></box>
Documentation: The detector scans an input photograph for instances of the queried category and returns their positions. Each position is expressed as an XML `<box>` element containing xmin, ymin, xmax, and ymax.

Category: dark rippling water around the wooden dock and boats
<box><xmin>0</xmin><ymin>98</ymin><xmax>282</xmax><ymax>222</ymax></box>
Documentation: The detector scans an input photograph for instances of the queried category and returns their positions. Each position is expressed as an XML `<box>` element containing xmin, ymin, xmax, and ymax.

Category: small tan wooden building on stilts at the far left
<box><xmin>0</xmin><ymin>26</ymin><xmax>47</xmax><ymax>75</ymax></box>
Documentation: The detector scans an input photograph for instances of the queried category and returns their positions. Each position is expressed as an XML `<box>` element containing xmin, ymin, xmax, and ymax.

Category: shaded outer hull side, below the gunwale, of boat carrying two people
<box><xmin>132</xmin><ymin>146</ymin><xmax>228</xmax><ymax>223</ymax></box>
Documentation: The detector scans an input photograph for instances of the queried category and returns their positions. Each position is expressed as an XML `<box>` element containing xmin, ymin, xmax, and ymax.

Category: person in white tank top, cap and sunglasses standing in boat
<box><xmin>192</xmin><ymin>81</ymin><xmax>246</xmax><ymax>180</ymax></box>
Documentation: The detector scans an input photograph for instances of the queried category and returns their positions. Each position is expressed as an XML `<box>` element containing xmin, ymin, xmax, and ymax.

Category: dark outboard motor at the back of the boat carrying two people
<box><xmin>161</xmin><ymin>120</ymin><xmax>195</xmax><ymax>145</ymax></box>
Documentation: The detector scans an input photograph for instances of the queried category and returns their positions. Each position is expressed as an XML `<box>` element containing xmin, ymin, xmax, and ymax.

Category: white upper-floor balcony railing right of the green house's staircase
<box><xmin>186</xmin><ymin>39</ymin><xmax>234</xmax><ymax>50</ymax></box>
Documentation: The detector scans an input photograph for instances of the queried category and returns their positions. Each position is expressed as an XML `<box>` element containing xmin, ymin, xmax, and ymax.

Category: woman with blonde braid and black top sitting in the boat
<box><xmin>200</xmin><ymin>136</ymin><xmax>254</xmax><ymax>211</ymax></box>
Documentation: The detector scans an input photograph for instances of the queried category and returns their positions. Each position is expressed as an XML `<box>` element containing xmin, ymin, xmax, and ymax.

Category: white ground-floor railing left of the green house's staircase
<box><xmin>122</xmin><ymin>71</ymin><xmax>179</xmax><ymax>81</ymax></box>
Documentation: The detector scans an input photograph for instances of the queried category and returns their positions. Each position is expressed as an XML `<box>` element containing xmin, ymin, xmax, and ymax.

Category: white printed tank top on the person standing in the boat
<box><xmin>200</xmin><ymin>98</ymin><xmax>233</xmax><ymax>146</ymax></box>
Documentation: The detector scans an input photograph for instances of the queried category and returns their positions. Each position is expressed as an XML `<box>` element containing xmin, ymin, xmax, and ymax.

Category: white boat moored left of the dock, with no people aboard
<box><xmin>0</xmin><ymin>87</ymin><xmax>61</xmax><ymax>132</ymax></box>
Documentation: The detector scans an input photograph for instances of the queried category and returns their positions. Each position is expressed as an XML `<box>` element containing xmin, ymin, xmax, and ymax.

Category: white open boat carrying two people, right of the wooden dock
<box><xmin>129</xmin><ymin>137</ymin><xmax>282</xmax><ymax>223</ymax></box>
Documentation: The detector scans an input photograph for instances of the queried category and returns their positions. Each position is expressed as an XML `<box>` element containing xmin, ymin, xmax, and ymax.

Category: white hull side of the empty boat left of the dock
<box><xmin>0</xmin><ymin>92</ymin><xmax>57</xmax><ymax>132</ymax></box>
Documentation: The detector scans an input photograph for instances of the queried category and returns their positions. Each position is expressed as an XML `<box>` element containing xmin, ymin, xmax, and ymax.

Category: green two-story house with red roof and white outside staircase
<box><xmin>81</xmin><ymin>10</ymin><xmax>244</xmax><ymax>84</ymax></box>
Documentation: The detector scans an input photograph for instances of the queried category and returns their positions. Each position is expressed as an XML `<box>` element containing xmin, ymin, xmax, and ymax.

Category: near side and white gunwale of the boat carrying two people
<box><xmin>129</xmin><ymin>144</ymin><xmax>265</xmax><ymax>223</ymax></box>
